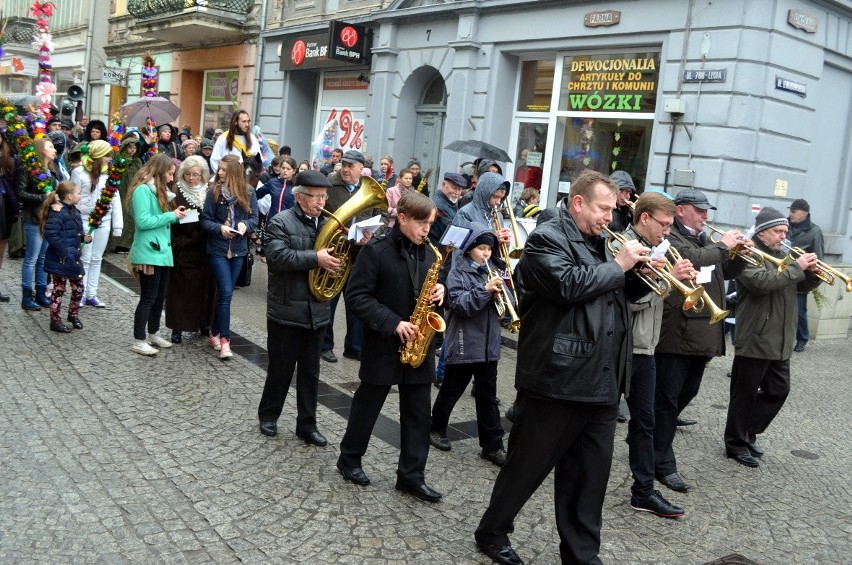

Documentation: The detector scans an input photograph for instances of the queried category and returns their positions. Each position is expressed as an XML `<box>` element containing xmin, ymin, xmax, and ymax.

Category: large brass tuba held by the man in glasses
<box><xmin>308</xmin><ymin>177</ymin><xmax>388</xmax><ymax>302</ymax></box>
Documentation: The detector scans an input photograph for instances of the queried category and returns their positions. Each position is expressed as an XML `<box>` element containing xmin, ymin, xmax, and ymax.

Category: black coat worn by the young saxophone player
<box><xmin>344</xmin><ymin>224</ymin><xmax>442</xmax><ymax>385</ymax></box>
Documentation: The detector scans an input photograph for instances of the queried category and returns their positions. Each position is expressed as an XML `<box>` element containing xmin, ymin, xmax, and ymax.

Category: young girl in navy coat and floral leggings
<box><xmin>40</xmin><ymin>180</ymin><xmax>92</xmax><ymax>333</ymax></box>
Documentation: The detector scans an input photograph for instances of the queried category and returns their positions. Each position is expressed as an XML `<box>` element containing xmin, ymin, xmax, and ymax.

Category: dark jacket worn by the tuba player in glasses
<box><xmin>263</xmin><ymin>206</ymin><xmax>331</xmax><ymax>329</ymax></box>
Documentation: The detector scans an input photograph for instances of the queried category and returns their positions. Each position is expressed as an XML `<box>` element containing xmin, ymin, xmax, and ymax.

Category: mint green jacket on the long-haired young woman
<box><xmin>130</xmin><ymin>184</ymin><xmax>178</xmax><ymax>267</ymax></box>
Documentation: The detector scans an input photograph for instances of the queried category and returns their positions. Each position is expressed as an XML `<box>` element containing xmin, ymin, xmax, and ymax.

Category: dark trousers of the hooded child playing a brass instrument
<box><xmin>432</xmin><ymin>361</ymin><xmax>505</xmax><ymax>452</ymax></box>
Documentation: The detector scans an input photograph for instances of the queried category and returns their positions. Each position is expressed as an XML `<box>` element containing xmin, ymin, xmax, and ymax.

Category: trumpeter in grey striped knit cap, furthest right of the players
<box><xmin>725</xmin><ymin>208</ymin><xmax>820</xmax><ymax>467</ymax></box>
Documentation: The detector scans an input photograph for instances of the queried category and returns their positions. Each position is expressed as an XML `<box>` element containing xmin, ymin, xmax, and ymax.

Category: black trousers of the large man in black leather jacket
<box><xmin>475</xmin><ymin>392</ymin><xmax>618</xmax><ymax>564</ymax></box>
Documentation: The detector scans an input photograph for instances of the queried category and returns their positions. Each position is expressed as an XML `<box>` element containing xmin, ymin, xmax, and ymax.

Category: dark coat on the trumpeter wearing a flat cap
<box><xmin>655</xmin><ymin>218</ymin><xmax>746</xmax><ymax>357</ymax></box>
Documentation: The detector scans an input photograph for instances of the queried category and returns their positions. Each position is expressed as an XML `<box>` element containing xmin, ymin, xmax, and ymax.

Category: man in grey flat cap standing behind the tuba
<box><xmin>322</xmin><ymin>149</ymin><xmax>371</xmax><ymax>363</ymax></box>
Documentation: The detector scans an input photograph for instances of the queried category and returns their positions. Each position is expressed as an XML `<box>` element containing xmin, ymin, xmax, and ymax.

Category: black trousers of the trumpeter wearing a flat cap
<box><xmin>652</xmin><ymin>353</ymin><xmax>707</xmax><ymax>477</ymax></box>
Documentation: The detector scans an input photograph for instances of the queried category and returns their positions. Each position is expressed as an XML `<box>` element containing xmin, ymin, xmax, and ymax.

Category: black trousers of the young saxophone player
<box><xmin>340</xmin><ymin>382</ymin><xmax>432</xmax><ymax>485</ymax></box>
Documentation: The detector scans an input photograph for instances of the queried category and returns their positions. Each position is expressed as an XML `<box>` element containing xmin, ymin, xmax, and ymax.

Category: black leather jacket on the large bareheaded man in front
<box><xmin>515</xmin><ymin>208</ymin><xmax>649</xmax><ymax>405</ymax></box>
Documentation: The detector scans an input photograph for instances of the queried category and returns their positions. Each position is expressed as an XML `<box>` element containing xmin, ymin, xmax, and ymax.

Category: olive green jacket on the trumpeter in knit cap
<box><xmin>735</xmin><ymin>238</ymin><xmax>820</xmax><ymax>361</ymax></box>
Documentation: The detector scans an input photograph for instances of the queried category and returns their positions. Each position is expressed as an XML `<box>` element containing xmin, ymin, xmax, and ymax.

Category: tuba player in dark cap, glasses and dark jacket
<box><xmin>257</xmin><ymin>171</ymin><xmax>340</xmax><ymax>447</ymax></box>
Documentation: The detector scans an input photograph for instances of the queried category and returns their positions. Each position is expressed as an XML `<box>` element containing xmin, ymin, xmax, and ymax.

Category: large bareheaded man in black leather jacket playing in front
<box><xmin>475</xmin><ymin>171</ymin><xmax>650</xmax><ymax>565</ymax></box>
